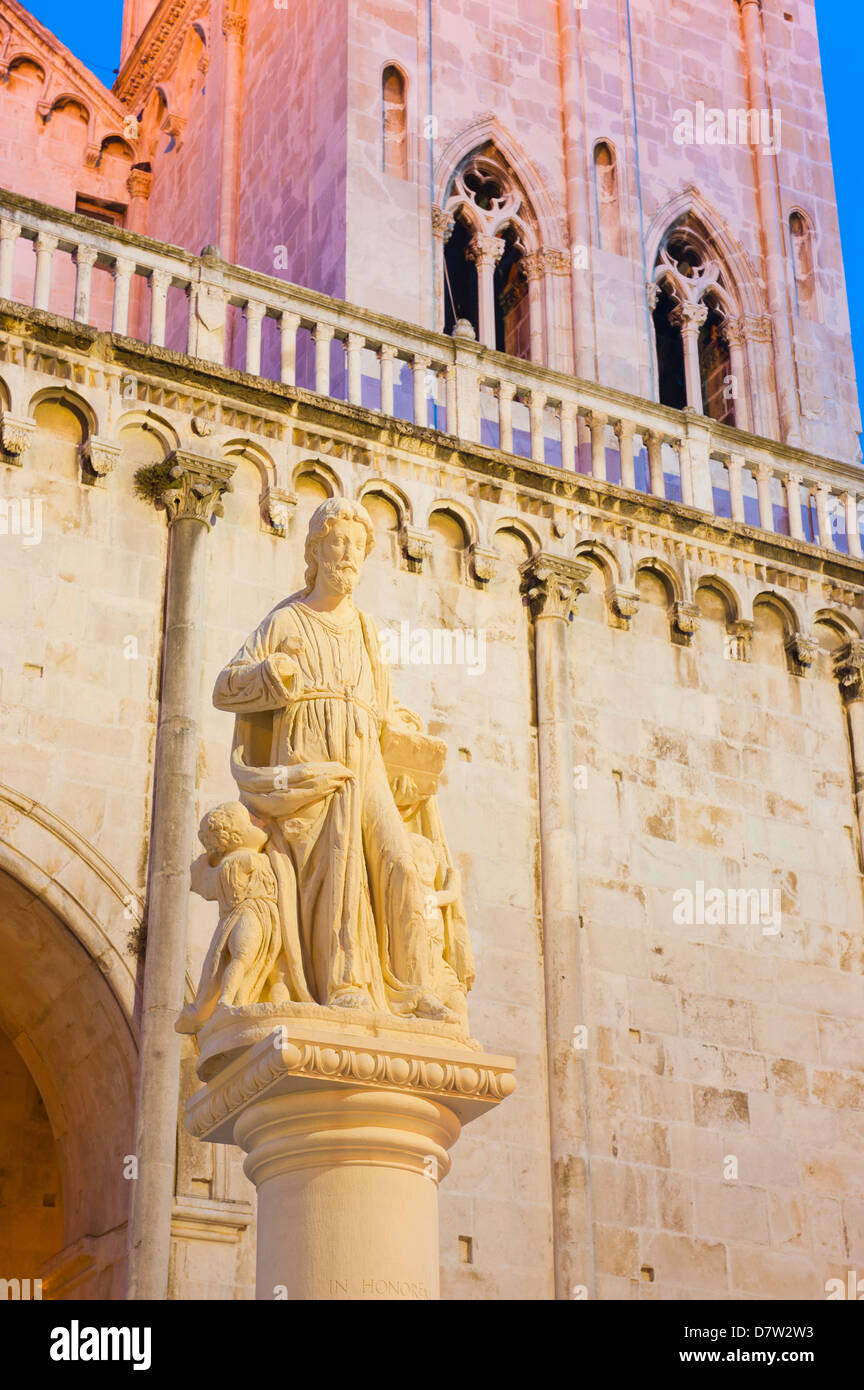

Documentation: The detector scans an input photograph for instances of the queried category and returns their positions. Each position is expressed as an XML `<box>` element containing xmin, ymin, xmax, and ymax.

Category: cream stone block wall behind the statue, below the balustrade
<box><xmin>0</xmin><ymin>304</ymin><xmax>864</xmax><ymax>1298</ymax></box>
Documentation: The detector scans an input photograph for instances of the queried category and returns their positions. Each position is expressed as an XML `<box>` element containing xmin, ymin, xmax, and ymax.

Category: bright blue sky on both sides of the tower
<box><xmin>23</xmin><ymin>0</ymin><xmax>864</xmax><ymax>436</ymax></box>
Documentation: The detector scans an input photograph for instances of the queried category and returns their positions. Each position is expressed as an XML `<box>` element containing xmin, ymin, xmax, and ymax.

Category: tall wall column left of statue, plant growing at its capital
<box><xmin>126</xmin><ymin>450</ymin><xmax>235</xmax><ymax>1300</ymax></box>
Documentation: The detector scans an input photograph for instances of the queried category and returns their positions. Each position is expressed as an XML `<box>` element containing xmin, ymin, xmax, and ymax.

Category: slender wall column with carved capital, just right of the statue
<box><xmin>522</xmin><ymin>553</ymin><xmax>593</xmax><ymax>1298</ymax></box>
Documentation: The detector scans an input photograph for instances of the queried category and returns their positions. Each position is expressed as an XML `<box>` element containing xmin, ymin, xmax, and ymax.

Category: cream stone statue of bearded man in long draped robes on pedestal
<box><xmin>214</xmin><ymin>498</ymin><xmax>474</xmax><ymax>1022</ymax></box>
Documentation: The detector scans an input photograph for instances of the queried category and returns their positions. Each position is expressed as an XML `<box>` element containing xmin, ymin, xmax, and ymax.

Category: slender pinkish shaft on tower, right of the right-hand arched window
<box><xmin>738</xmin><ymin>0</ymin><xmax>800</xmax><ymax>443</ymax></box>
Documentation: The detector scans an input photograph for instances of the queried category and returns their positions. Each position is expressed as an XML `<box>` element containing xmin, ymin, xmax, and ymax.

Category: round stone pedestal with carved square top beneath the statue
<box><xmin>186</xmin><ymin>1005</ymin><xmax>515</xmax><ymax>1300</ymax></box>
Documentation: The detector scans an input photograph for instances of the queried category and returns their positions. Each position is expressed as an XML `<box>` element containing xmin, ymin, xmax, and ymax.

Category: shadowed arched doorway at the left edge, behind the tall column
<box><xmin>0</xmin><ymin>840</ymin><xmax>138</xmax><ymax>1300</ymax></box>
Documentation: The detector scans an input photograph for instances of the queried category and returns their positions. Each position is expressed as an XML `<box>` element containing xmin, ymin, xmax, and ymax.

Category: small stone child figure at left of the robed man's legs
<box><xmin>176</xmin><ymin>801</ymin><xmax>281</xmax><ymax>1033</ymax></box>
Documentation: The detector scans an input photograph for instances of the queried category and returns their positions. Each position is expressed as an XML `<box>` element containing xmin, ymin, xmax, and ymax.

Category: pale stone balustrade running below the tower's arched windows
<box><xmin>0</xmin><ymin>192</ymin><xmax>864</xmax><ymax>557</ymax></box>
